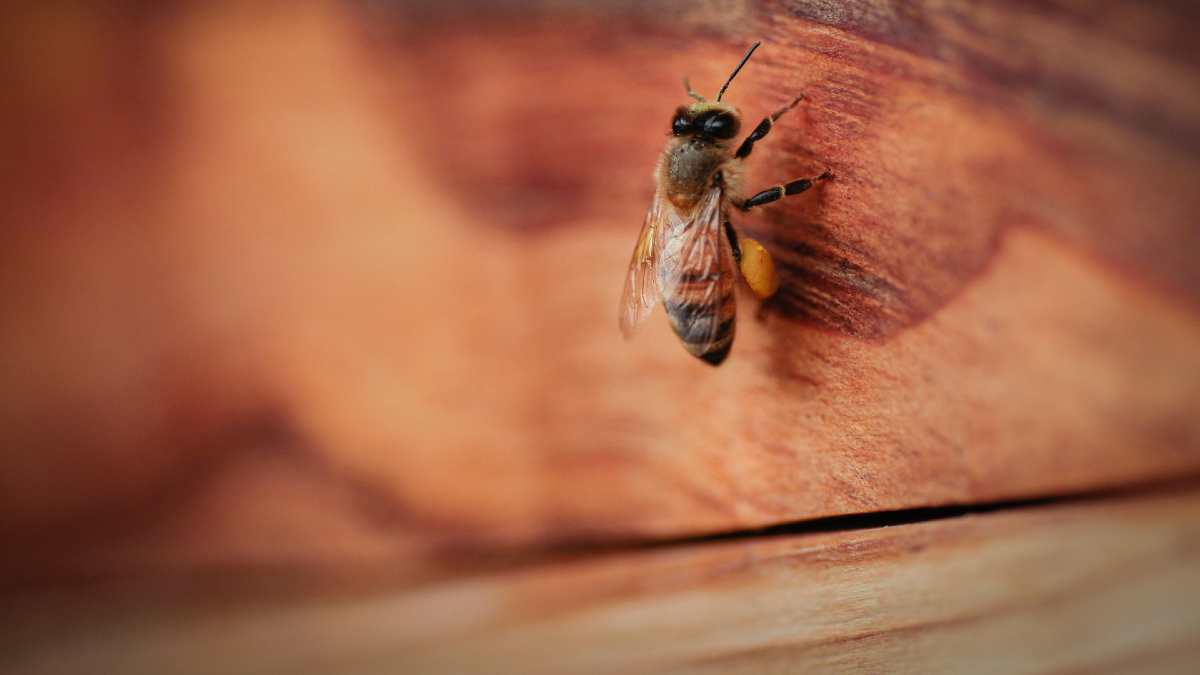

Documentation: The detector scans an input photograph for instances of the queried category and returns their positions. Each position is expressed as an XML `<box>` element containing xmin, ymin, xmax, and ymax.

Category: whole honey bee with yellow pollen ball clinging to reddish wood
<box><xmin>619</xmin><ymin>42</ymin><xmax>833</xmax><ymax>365</ymax></box>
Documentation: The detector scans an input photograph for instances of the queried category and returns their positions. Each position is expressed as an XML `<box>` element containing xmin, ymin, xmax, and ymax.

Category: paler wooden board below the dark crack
<box><xmin>0</xmin><ymin>488</ymin><xmax>1200</xmax><ymax>675</ymax></box>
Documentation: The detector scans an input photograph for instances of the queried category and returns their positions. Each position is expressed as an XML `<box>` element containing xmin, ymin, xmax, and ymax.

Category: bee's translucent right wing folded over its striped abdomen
<box><xmin>660</xmin><ymin>186</ymin><xmax>734</xmax><ymax>354</ymax></box>
